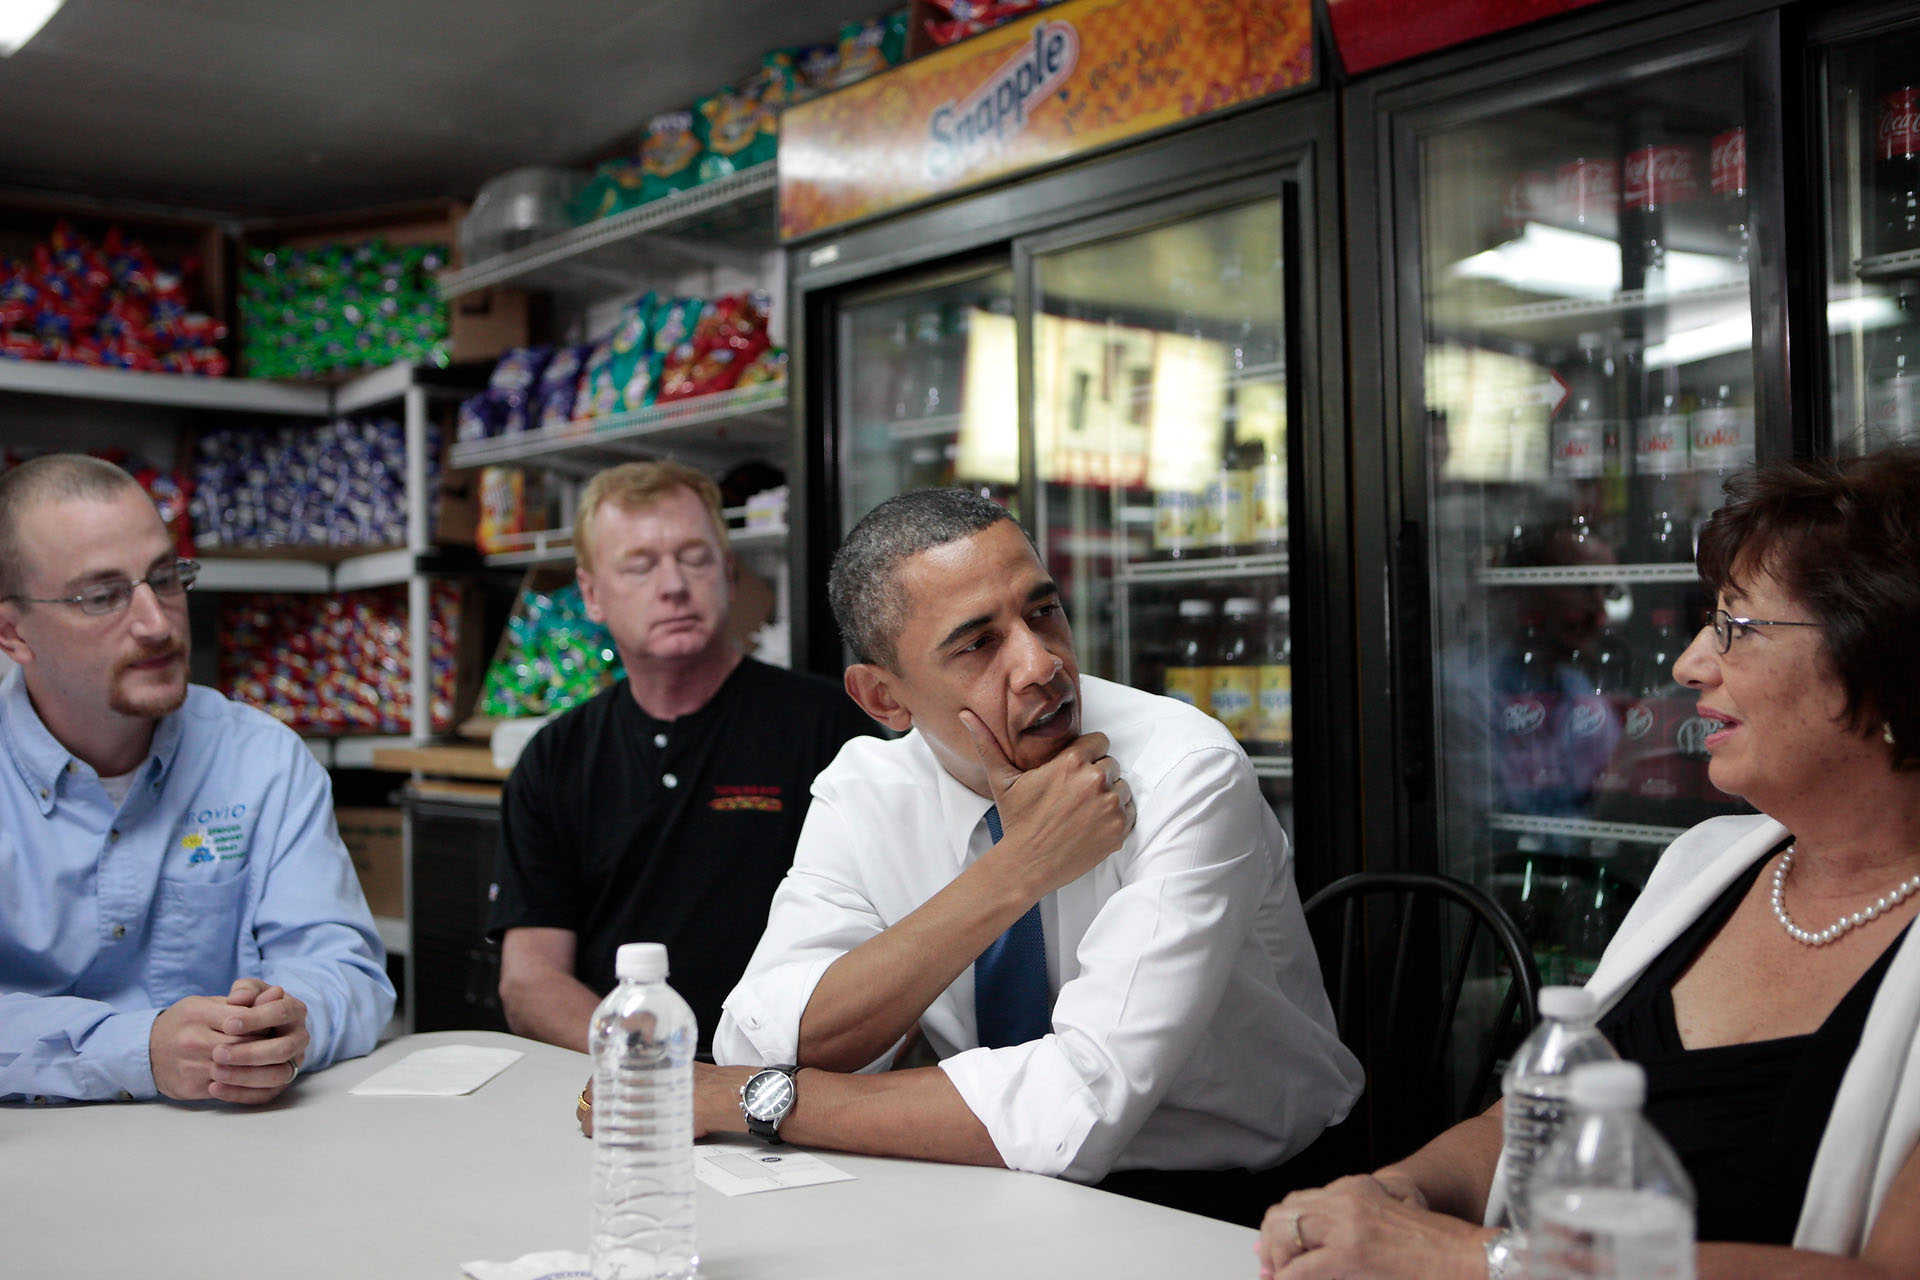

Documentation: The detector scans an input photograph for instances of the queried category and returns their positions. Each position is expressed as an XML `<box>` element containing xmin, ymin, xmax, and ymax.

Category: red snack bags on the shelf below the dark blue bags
<box><xmin>219</xmin><ymin>581</ymin><xmax>465</xmax><ymax>735</ymax></box>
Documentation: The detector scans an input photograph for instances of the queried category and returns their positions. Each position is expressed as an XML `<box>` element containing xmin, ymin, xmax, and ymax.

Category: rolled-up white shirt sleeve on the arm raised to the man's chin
<box><xmin>941</xmin><ymin>748</ymin><xmax>1273</xmax><ymax>1182</ymax></box>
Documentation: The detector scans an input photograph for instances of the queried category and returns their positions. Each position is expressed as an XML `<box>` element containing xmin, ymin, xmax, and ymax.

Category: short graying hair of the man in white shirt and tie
<box><xmin>828</xmin><ymin>489</ymin><xmax>1031</xmax><ymax>670</ymax></box>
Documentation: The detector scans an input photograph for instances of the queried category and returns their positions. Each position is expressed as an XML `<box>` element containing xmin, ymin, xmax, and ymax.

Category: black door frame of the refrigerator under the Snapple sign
<box><xmin>787</xmin><ymin>86</ymin><xmax>1359</xmax><ymax>892</ymax></box>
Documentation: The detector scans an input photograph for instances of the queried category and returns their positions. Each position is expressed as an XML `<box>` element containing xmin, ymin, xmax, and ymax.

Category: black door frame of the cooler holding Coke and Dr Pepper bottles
<box><xmin>1342</xmin><ymin>2</ymin><xmax>1812</xmax><ymax>871</ymax></box>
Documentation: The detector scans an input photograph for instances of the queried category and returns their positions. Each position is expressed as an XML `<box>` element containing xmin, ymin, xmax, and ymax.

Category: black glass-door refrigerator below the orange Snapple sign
<box><xmin>789</xmin><ymin>96</ymin><xmax>1356</xmax><ymax>892</ymax></box>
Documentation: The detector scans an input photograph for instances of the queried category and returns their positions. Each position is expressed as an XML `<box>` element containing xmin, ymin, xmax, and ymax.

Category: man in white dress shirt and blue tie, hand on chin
<box><xmin>695</xmin><ymin>489</ymin><xmax>1361</xmax><ymax>1221</ymax></box>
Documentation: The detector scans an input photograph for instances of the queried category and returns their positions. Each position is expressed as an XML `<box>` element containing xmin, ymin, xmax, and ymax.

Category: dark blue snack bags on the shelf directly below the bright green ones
<box><xmin>192</xmin><ymin>418</ymin><xmax>440</xmax><ymax>551</ymax></box>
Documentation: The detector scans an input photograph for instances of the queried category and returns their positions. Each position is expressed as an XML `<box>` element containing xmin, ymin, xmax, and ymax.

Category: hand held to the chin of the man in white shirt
<box><xmin>960</xmin><ymin>710</ymin><xmax>1135</xmax><ymax>902</ymax></box>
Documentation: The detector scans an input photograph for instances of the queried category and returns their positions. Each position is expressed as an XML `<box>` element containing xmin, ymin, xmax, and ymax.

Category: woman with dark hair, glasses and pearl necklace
<box><xmin>1260</xmin><ymin>449</ymin><xmax>1920</xmax><ymax>1280</ymax></box>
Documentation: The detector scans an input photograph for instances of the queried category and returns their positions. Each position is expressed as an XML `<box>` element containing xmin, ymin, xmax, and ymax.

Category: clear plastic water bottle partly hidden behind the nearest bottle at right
<box><xmin>1500</xmin><ymin>986</ymin><xmax>1619</xmax><ymax>1232</ymax></box>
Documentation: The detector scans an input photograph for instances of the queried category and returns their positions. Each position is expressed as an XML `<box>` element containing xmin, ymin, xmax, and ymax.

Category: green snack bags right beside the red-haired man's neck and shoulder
<box><xmin>476</xmin><ymin>570</ymin><xmax>624</xmax><ymax>720</ymax></box>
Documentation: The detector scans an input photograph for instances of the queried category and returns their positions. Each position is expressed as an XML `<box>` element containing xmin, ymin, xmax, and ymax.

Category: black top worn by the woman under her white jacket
<box><xmin>1599</xmin><ymin>842</ymin><xmax>1905</xmax><ymax>1244</ymax></box>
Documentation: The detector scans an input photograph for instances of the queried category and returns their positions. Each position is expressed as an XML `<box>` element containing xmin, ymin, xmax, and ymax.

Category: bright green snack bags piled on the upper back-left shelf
<box><xmin>240</xmin><ymin>238</ymin><xmax>447</xmax><ymax>378</ymax></box>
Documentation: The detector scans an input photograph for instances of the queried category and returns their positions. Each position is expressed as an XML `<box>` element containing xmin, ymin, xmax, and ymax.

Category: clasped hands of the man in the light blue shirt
<box><xmin>148</xmin><ymin>979</ymin><xmax>309</xmax><ymax>1105</ymax></box>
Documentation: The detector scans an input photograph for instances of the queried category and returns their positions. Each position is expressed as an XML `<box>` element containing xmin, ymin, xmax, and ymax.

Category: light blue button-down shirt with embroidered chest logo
<box><xmin>0</xmin><ymin>670</ymin><xmax>394</xmax><ymax>1100</ymax></box>
